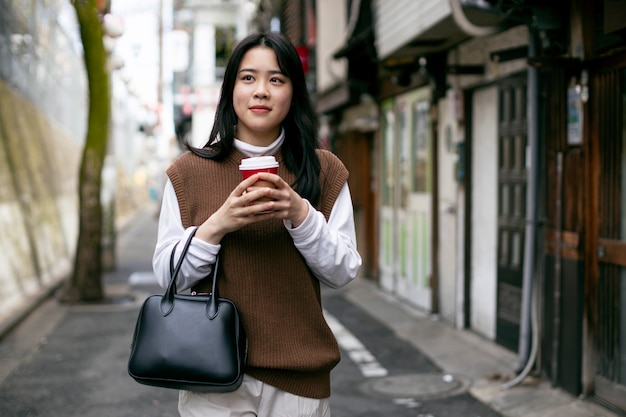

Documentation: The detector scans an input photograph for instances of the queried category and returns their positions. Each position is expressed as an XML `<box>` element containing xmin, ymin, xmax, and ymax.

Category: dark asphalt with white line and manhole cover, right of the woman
<box><xmin>324</xmin><ymin>291</ymin><xmax>500</xmax><ymax>417</ymax></box>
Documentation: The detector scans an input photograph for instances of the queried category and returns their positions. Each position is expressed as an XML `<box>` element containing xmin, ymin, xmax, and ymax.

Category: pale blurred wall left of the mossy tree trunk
<box><xmin>0</xmin><ymin>1</ymin><xmax>87</xmax><ymax>327</ymax></box>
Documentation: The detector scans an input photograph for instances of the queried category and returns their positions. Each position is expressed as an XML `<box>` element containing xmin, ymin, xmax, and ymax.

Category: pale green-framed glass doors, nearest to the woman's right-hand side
<box><xmin>379</xmin><ymin>89</ymin><xmax>433</xmax><ymax>311</ymax></box>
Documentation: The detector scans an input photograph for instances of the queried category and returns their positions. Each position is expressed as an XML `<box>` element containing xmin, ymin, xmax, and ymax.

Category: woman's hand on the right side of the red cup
<box><xmin>248</xmin><ymin>172</ymin><xmax>309</xmax><ymax>227</ymax></box>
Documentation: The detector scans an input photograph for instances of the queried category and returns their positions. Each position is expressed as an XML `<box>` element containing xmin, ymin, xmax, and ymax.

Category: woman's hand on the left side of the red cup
<box><xmin>195</xmin><ymin>175</ymin><xmax>274</xmax><ymax>245</ymax></box>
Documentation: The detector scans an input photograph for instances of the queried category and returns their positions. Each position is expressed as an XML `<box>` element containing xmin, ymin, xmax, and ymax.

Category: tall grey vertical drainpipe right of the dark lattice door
<box><xmin>501</xmin><ymin>28</ymin><xmax>539</xmax><ymax>389</ymax></box>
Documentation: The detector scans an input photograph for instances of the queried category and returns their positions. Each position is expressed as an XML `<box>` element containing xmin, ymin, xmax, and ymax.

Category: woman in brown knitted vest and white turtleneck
<box><xmin>153</xmin><ymin>33</ymin><xmax>361</xmax><ymax>417</ymax></box>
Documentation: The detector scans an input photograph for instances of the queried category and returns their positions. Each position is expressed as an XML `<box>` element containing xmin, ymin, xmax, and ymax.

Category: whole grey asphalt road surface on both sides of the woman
<box><xmin>0</xmin><ymin>206</ymin><xmax>499</xmax><ymax>417</ymax></box>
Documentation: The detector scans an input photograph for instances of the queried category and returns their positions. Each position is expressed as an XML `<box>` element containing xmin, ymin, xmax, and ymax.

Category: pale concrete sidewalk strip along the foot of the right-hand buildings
<box><xmin>341</xmin><ymin>279</ymin><xmax>619</xmax><ymax>417</ymax></box>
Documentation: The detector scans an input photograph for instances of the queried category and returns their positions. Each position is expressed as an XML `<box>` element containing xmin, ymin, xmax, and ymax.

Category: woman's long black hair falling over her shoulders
<box><xmin>187</xmin><ymin>32</ymin><xmax>321</xmax><ymax>204</ymax></box>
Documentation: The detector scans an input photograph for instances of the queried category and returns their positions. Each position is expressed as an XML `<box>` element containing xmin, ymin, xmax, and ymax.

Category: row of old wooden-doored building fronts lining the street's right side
<box><xmin>316</xmin><ymin>0</ymin><xmax>626</xmax><ymax>410</ymax></box>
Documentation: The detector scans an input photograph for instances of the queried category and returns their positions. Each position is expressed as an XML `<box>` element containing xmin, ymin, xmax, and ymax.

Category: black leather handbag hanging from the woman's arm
<box><xmin>128</xmin><ymin>226</ymin><xmax>247</xmax><ymax>392</ymax></box>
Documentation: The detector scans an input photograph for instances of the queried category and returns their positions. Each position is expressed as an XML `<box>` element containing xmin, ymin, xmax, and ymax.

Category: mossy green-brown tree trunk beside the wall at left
<box><xmin>61</xmin><ymin>0</ymin><xmax>111</xmax><ymax>303</ymax></box>
